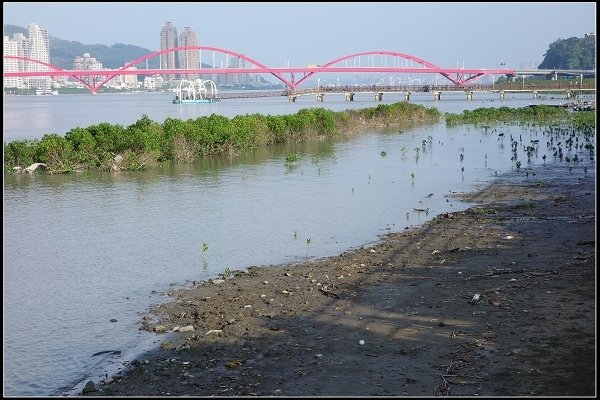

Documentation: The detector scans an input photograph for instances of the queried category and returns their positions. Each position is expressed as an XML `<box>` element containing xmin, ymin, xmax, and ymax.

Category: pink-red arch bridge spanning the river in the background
<box><xmin>4</xmin><ymin>46</ymin><xmax>515</xmax><ymax>93</ymax></box>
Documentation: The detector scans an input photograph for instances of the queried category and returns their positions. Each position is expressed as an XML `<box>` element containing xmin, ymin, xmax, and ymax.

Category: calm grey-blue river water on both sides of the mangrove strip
<box><xmin>3</xmin><ymin>94</ymin><xmax>596</xmax><ymax>396</ymax></box>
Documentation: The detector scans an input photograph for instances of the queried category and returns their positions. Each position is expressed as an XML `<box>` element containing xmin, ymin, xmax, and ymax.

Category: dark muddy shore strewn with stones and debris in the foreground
<box><xmin>86</xmin><ymin>165</ymin><xmax>596</xmax><ymax>396</ymax></box>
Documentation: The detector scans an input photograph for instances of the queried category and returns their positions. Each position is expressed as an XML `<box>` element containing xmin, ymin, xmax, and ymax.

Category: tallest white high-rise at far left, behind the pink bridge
<box><xmin>25</xmin><ymin>23</ymin><xmax>52</xmax><ymax>89</ymax></box>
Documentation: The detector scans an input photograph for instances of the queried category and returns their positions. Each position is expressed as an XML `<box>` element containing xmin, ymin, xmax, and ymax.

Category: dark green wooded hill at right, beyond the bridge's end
<box><xmin>538</xmin><ymin>34</ymin><xmax>596</xmax><ymax>69</ymax></box>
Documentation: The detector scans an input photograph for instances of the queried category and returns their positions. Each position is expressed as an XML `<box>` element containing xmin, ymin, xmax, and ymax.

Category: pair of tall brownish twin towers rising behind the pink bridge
<box><xmin>160</xmin><ymin>22</ymin><xmax>201</xmax><ymax>80</ymax></box>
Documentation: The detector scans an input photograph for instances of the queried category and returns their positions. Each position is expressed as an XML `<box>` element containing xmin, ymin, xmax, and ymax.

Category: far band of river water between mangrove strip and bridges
<box><xmin>3</xmin><ymin>92</ymin><xmax>580</xmax><ymax>141</ymax></box>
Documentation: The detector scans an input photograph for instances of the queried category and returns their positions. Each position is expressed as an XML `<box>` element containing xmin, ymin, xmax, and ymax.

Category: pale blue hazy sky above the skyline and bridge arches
<box><xmin>3</xmin><ymin>2</ymin><xmax>596</xmax><ymax>68</ymax></box>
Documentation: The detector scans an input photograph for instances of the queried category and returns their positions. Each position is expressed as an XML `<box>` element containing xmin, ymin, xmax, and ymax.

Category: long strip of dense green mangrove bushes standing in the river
<box><xmin>4</xmin><ymin>102</ymin><xmax>441</xmax><ymax>173</ymax></box>
